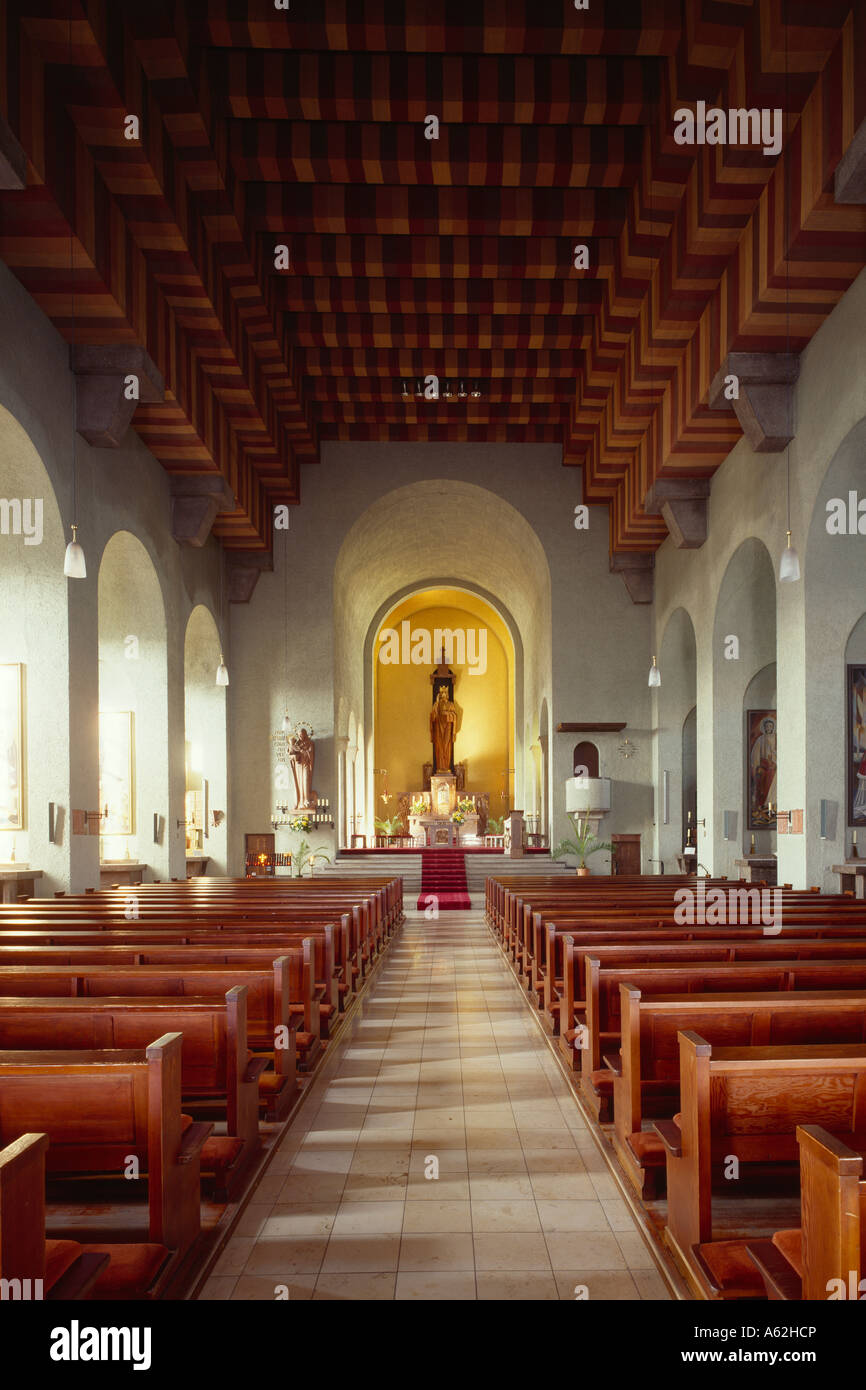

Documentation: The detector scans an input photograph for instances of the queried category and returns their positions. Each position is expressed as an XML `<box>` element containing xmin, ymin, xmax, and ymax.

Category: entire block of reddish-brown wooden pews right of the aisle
<box><xmin>487</xmin><ymin>876</ymin><xmax>866</xmax><ymax>1300</ymax></box>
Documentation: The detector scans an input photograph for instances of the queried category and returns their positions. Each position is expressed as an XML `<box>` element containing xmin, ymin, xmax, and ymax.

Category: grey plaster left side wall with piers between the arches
<box><xmin>0</xmin><ymin>264</ymin><xmax>228</xmax><ymax>894</ymax></box>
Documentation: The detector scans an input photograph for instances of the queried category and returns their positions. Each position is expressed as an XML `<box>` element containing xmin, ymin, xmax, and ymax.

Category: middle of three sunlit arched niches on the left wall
<box><xmin>97</xmin><ymin>531</ymin><xmax>168</xmax><ymax>878</ymax></box>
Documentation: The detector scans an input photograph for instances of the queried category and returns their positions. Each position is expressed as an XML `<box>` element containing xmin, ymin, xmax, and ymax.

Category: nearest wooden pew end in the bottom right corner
<box><xmin>750</xmin><ymin>1125</ymin><xmax>866</xmax><ymax>1302</ymax></box>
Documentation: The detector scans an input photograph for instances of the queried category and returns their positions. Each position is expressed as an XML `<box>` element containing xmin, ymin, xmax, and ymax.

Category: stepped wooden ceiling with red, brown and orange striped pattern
<box><xmin>0</xmin><ymin>0</ymin><xmax>866</xmax><ymax>552</ymax></box>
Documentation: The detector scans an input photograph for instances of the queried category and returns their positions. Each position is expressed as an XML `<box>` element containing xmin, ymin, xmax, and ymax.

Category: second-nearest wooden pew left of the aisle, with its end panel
<box><xmin>0</xmin><ymin>1033</ymin><xmax>213</xmax><ymax>1297</ymax></box>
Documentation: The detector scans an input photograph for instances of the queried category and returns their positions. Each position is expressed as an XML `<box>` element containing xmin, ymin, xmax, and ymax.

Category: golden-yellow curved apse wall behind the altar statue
<box><xmin>374</xmin><ymin>588</ymin><xmax>514</xmax><ymax>819</ymax></box>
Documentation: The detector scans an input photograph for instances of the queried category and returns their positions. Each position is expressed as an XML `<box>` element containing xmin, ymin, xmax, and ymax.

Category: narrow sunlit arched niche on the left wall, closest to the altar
<box><xmin>183</xmin><ymin>603</ymin><xmax>228</xmax><ymax>874</ymax></box>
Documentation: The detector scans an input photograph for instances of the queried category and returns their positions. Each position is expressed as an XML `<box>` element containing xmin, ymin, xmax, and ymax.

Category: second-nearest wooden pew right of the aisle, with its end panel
<box><xmin>655</xmin><ymin>1030</ymin><xmax>866</xmax><ymax>1298</ymax></box>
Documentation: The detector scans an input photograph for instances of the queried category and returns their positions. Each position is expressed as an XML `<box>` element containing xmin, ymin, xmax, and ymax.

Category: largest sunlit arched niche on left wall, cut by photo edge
<box><xmin>0</xmin><ymin>406</ymin><xmax>67</xmax><ymax>895</ymax></box>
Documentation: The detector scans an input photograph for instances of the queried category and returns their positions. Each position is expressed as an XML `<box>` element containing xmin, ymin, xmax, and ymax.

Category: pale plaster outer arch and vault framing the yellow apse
<box><xmin>334</xmin><ymin>480</ymin><xmax>552</xmax><ymax>830</ymax></box>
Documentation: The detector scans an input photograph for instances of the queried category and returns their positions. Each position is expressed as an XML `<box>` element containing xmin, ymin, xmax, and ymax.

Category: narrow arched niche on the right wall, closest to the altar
<box><xmin>653</xmin><ymin>607</ymin><xmax>698</xmax><ymax>873</ymax></box>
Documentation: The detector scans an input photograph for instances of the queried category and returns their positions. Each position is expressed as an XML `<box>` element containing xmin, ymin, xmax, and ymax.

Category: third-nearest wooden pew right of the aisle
<box><xmin>606</xmin><ymin>984</ymin><xmax>866</xmax><ymax>1197</ymax></box>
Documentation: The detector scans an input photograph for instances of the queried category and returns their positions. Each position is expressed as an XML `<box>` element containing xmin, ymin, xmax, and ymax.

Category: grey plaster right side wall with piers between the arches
<box><xmin>655</xmin><ymin>261</ymin><xmax>866</xmax><ymax>891</ymax></box>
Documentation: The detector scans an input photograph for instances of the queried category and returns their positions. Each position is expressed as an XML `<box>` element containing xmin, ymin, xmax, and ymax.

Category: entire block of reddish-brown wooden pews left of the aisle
<box><xmin>0</xmin><ymin>877</ymin><xmax>403</xmax><ymax>1298</ymax></box>
